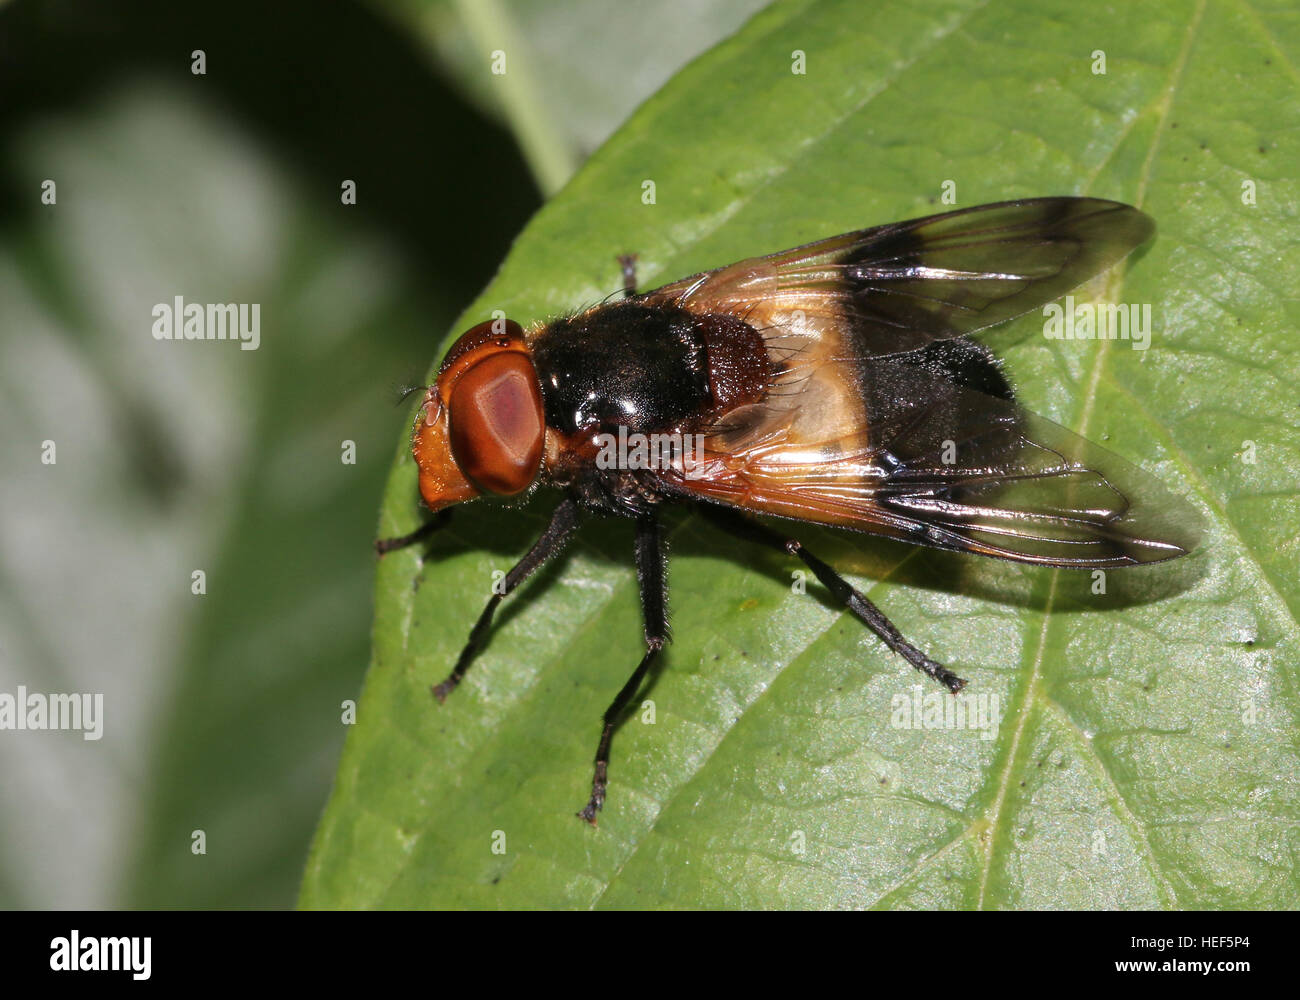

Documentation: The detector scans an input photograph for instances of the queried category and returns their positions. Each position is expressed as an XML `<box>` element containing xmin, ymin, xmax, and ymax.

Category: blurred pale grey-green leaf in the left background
<box><xmin>0</xmin><ymin>82</ymin><xmax>451</xmax><ymax>906</ymax></box>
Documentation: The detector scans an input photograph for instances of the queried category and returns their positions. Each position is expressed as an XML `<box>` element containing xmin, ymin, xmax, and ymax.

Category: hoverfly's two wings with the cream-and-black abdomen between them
<box><xmin>641</xmin><ymin>198</ymin><xmax>1200</xmax><ymax>568</ymax></box>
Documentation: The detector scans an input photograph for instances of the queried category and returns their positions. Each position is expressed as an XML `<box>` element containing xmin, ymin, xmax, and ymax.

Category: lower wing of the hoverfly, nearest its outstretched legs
<box><xmin>666</xmin><ymin>345</ymin><xmax>1200</xmax><ymax>568</ymax></box>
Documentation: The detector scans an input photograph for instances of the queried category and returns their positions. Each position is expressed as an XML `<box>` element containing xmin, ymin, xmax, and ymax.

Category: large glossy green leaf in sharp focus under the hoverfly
<box><xmin>302</xmin><ymin>0</ymin><xmax>1300</xmax><ymax>908</ymax></box>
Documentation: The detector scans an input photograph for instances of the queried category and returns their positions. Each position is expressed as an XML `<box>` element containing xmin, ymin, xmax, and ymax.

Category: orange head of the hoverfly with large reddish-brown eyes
<box><xmin>411</xmin><ymin>320</ymin><xmax>546</xmax><ymax>510</ymax></box>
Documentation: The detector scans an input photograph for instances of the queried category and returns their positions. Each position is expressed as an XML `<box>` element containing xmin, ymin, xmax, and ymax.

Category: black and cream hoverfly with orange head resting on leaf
<box><xmin>376</xmin><ymin>198</ymin><xmax>1197</xmax><ymax>826</ymax></box>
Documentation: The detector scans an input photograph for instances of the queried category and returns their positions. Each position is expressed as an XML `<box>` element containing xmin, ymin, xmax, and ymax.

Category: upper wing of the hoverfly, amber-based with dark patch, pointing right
<box><xmin>640</xmin><ymin>198</ymin><xmax>1154</xmax><ymax>355</ymax></box>
